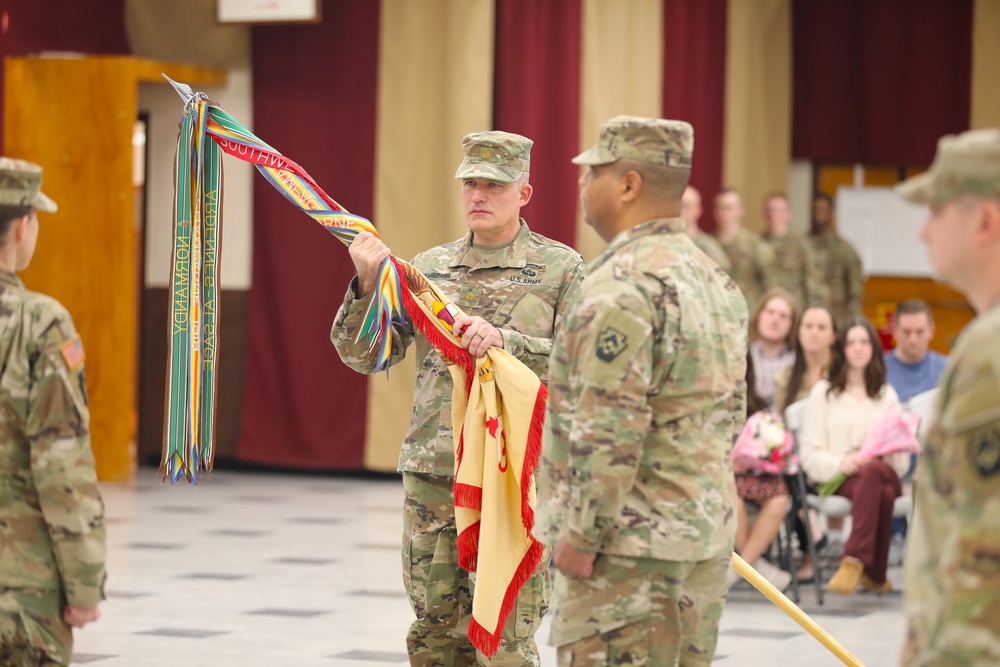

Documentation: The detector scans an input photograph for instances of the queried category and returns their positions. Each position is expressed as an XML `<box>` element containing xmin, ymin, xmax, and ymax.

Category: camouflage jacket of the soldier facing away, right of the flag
<box><xmin>535</xmin><ymin>218</ymin><xmax>747</xmax><ymax>561</ymax></box>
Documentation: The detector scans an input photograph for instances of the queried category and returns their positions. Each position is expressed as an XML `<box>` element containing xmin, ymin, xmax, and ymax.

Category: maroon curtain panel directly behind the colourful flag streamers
<box><xmin>237</xmin><ymin>0</ymin><xmax>379</xmax><ymax>469</ymax></box>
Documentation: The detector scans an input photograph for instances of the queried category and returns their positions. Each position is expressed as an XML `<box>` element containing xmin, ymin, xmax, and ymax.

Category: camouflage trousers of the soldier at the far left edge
<box><xmin>0</xmin><ymin>588</ymin><xmax>73</xmax><ymax>667</ymax></box>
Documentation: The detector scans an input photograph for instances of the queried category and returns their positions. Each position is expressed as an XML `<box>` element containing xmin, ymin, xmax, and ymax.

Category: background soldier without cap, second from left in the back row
<box><xmin>714</xmin><ymin>188</ymin><xmax>774</xmax><ymax>308</ymax></box>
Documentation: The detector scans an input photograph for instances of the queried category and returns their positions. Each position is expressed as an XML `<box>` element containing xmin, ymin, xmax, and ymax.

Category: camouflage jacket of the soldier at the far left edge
<box><xmin>0</xmin><ymin>273</ymin><xmax>106</xmax><ymax>652</ymax></box>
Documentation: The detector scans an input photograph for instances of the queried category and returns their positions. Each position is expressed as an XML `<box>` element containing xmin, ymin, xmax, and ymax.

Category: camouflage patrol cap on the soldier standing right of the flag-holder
<box><xmin>573</xmin><ymin>116</ymin><xmax>694</xmax><ymax>169</ymax></box>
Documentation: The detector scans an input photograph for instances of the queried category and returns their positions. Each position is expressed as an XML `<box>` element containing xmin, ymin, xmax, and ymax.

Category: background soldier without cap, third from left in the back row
<box><xmin>764</xmin><ymin>192</ymin><xmax>830</xmax><ymax>308</ymax></box>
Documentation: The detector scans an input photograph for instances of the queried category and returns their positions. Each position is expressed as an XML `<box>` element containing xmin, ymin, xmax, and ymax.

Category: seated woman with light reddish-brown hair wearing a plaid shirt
<box><xmin>749</xmin><ymin>287</ymin><xmax>798</xmax><ymax>405</ymax></box>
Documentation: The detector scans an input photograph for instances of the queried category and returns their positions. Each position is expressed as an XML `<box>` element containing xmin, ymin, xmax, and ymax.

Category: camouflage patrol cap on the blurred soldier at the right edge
<box><xmin>896</xmin><ymin>129</ymin><xmax>1000</xmax><ymax>204</ymax></box>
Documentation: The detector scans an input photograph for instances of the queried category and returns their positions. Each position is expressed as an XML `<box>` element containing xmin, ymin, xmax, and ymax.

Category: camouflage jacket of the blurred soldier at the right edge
<box><xmin>903</xmin><ymin>300</ymin><xmax>1000</xmax><ymax>666</ymax></box>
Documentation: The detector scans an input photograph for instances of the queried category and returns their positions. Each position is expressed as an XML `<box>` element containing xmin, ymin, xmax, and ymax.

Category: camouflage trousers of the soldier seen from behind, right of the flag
<box><xmin>550</xmin><ymin>554</ymin><xmax>730</xmax><ymax>667</ymax></box>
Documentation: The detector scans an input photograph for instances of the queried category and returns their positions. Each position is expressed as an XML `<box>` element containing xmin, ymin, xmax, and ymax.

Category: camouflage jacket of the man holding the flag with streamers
<box><xmin>330</xmin><ymin>220</ymin><xmax>585</xmax><ymax>477</ymax></box>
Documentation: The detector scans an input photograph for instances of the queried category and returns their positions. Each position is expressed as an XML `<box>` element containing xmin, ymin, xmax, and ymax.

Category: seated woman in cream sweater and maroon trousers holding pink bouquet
<box><xmin>801</xmin><ymin>317</ymin><xmax>909</xmax><ymax>595</ymax></box>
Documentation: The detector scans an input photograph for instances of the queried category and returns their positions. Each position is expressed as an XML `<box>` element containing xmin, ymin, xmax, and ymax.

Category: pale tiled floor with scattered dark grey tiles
<box><xmin>73</xmin><ymin>469</ymin><xmax>903</xmax><ymax>667</ymax></box>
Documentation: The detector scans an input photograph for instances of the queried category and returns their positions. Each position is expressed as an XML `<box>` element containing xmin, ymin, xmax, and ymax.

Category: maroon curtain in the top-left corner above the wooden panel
<box><xmin>0</xmin><ymin>0</ymin><xmax>130</xmax><ymax>153</ymax></box>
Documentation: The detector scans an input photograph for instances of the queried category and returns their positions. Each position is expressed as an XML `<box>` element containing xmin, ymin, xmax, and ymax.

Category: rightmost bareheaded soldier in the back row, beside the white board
<box><xmin>809</xmin><ymin>193</ymin><xmax>865</xmax><ymax>325</ymax></box>
